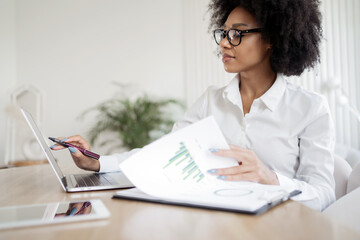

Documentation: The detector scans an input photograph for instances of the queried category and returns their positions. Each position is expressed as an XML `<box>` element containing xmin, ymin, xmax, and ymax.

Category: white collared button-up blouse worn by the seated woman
<box><xmin>100</xmin><ymin>75</ymin><xmax>335</xmax><ymax>210</ymax></box>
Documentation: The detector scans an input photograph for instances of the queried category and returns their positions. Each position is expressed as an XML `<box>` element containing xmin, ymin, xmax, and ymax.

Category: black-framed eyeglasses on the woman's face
<box><xmin>214</xmin><ymin>28</ymin><xmax>262</xmax><ymax>46</ymax></box>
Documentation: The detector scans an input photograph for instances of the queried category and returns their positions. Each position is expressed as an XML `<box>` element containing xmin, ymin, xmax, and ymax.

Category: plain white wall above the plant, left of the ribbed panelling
<box><xmin>0</xmin><ymin>0</ymin><xmax>184</xmax><ymax>164</ymax></box>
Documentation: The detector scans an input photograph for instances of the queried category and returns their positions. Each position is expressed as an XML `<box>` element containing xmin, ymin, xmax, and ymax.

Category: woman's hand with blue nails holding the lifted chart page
<box><xmin>208</xmin><ymin>145</ymin><xmax>279</xmax><ymax>185</ymax></box>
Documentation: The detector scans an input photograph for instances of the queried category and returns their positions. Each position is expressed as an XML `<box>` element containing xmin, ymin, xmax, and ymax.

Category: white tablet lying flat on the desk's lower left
<box><xmin>0</xmin><ymin>199</ymin><xmax>110</xmax><ymax>229</ymax></box>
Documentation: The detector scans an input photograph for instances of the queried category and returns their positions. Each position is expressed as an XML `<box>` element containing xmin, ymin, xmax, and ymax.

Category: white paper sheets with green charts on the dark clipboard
<box><xmin>120</xmin><ymin>117</ymin><xmax>292</xmax><ymax>211</ymax></box>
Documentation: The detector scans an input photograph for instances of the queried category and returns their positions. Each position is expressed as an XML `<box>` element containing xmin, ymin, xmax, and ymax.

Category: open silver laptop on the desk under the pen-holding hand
<box><xmin>21</xmin><ymin>108</ymin><xmax>134</xmax><ymax>192</ymax></box>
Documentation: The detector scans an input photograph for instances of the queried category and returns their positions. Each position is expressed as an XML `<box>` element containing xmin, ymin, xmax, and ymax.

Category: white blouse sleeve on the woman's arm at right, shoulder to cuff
<box><xmin>276</xmin><ymin>98</ymin><xmax>335</xmax><ymax>211</ymax></box>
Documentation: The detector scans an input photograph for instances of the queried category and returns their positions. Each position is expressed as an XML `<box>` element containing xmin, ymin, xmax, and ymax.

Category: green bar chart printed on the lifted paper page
<box><xmin>163</xmin><ymin>142</ymin><xmax>205</xmax><ymax>182</ymax></box>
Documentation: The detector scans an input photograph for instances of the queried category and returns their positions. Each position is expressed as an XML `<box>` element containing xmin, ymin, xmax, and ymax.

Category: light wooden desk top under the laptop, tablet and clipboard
<box><xmin>0</xmin><ymin>165</ymin><xmax>360</xmax><ymax>240</ymax></box>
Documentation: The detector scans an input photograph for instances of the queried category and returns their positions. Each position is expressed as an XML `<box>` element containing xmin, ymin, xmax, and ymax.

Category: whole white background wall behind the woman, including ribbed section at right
<box><xmin>0</xmin><ymin>0</ymin><xmax>360</xmax><ymax>165</ymax></box>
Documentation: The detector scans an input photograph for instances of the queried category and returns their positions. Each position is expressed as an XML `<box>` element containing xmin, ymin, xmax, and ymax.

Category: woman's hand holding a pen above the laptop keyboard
<box><xmin>50</xmin><ymin>135</ymin><xmax>100</xmax><ymax>172</ymax></box>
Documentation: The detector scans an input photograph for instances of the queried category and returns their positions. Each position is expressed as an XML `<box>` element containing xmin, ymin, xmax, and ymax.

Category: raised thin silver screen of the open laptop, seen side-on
<box><xmin>21</xmin><ymin>109</ymin><xmax>64</xmax><ymax>180</ymax></box>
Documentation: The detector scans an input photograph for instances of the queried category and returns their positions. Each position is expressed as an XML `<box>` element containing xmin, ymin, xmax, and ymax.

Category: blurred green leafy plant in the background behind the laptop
<box><xmin>81</xmin><ymin>89</ymin><xmax>184</xmax><ymax>151</ymax></box>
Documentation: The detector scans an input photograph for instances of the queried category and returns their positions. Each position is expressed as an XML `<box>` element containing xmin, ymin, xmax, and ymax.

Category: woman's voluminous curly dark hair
<box><xmin>209</xmin><ymin>0</ymin><xmax>322</xmax><ymax>76</ymax></box>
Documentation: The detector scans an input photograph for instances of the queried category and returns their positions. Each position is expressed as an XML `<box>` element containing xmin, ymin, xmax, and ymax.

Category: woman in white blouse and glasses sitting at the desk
<box><xmin>54</xmin><ymin>0</ymin><xmax>335</xmax><ymax>210</ymax></box>
